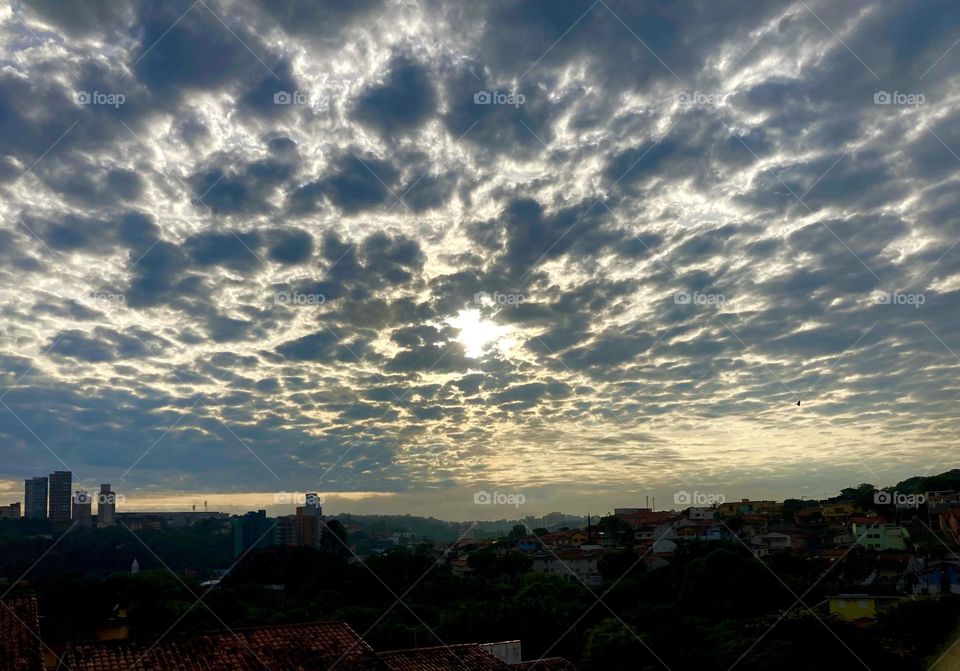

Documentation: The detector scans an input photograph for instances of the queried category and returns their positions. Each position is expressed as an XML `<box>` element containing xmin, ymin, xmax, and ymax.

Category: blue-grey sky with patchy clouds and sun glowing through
<box><xmin>0</xmin><ymin>0</ymin><xmax>960</xmax><ymax>519</ymax></box>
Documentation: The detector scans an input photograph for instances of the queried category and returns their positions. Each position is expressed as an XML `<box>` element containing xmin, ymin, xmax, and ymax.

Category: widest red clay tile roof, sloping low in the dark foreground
<box><xmin>61</xmin><ymin>622</ymin><xmax>387</xmax><ymax>671</ymax></box>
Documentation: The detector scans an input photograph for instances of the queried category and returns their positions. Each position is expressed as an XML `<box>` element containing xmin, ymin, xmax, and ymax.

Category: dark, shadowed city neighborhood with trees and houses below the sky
<box><xmin>0</xmin><ymin>470</ymin><xmax>960</xmax><ymax>671</ymax></box>
